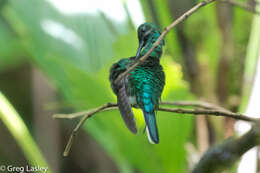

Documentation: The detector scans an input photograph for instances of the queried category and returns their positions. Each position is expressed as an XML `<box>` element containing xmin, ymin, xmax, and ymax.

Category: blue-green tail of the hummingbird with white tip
<box><xmin>142</xmin><ymin>94</ymin><xmax>159</xmax><ymax>144</ymax></box>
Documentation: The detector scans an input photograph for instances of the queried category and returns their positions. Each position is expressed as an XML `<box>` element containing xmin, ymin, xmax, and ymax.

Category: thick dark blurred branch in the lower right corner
<box><xmin>192</xmin><ymin>121</ymin><xmax>260</xmax><ymax>173</ymax></box>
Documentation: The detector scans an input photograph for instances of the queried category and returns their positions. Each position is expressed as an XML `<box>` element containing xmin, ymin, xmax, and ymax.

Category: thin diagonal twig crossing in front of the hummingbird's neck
<box><xmin>115</xmin><ymin>0</ymin><xmax>215</xmax><ymax>83</ymax></box>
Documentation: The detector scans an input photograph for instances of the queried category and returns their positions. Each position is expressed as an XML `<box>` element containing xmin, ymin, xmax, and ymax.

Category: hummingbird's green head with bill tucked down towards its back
<box><xmin>136</xmin><ymin>22</ymin><xmax>164</xmax><ymax>58</ymax></box>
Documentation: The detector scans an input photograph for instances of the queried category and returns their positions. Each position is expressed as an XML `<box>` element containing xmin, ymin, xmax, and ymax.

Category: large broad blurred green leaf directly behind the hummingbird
<box><xmin>0</xmin><ymin>0</ymin><xmax>192</xmax><ymax>172</ymax></box>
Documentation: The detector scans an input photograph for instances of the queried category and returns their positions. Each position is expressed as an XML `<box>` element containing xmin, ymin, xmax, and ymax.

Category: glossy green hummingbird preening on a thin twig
<box><xmin>109</xmin><ymin>23</ymin><xmax>165</xmax><ymax>144</ymax></box>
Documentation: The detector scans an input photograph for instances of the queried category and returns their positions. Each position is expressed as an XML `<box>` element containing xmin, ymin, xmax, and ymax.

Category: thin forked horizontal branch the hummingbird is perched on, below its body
<box><xmin>53</xmin><ymin>101</ymin><xmax>258</xmax><ymax>156</ymax></box>
